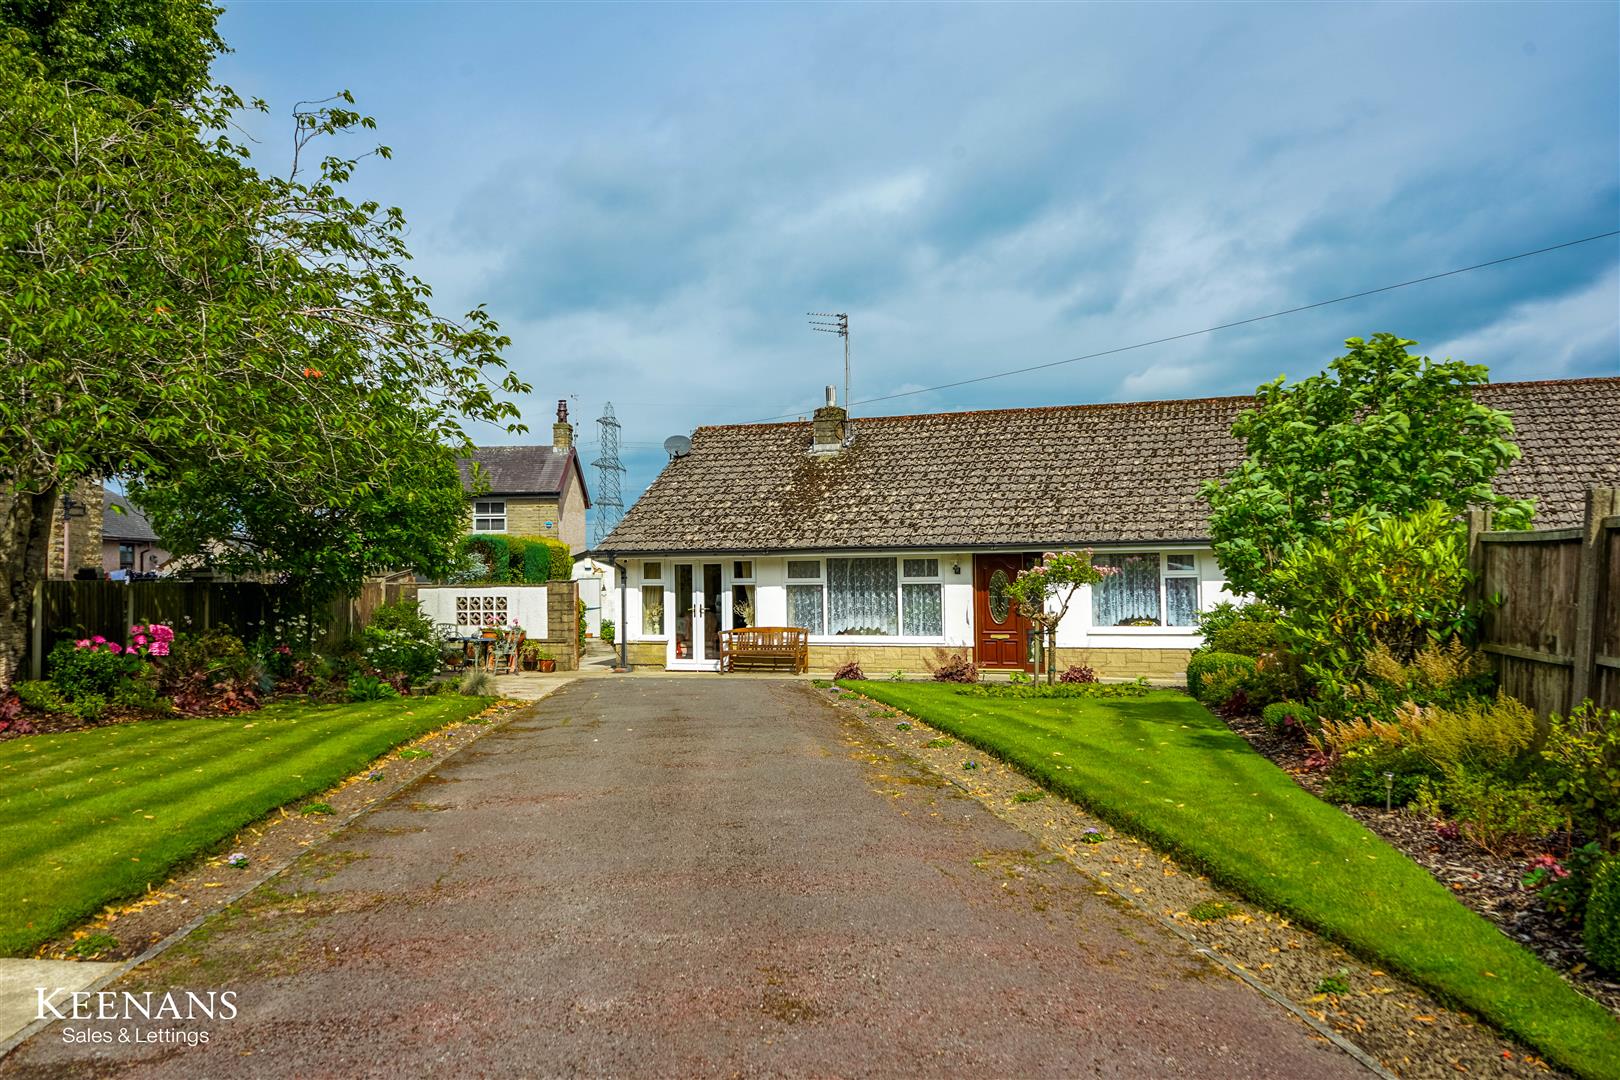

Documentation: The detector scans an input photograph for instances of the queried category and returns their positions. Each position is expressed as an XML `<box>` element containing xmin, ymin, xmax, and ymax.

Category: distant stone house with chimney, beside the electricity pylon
<box><xmin>458</xmin><ymin>400</ymin><xmax>591</xmax><ymax>554</ymax></box>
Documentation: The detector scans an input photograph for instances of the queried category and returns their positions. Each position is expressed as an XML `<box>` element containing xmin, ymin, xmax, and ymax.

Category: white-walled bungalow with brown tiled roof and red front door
<box><xmin>593</xmin><ymin>379</ymin><xmax>1620</xmax><ymax>677</ymax></box>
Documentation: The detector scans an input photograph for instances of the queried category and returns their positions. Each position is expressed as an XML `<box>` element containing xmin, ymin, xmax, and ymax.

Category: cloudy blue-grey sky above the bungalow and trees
<box><xmin>217</xmin><ymin>0</ymin><xmax>1620</xmax><ymax>531</ymax></box>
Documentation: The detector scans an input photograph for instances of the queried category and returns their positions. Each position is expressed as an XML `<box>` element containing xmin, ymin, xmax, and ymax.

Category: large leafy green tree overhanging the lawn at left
<box><xmin>0</xmin><ymin>12</ymin><xmax>527</xmax><ymax>687</ymax></box>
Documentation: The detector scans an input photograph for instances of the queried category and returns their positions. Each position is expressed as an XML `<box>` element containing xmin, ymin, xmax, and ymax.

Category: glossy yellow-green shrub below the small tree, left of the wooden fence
<box><xmin>1272</xmin><ymin>504</ymin><xmax>1471</xmax><ymax>698</ymax></box>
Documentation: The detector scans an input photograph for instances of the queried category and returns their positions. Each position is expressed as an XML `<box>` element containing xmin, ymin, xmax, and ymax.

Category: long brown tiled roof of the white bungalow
<box><xmin>593</xmin><ymin>379</ymin><xmax>1620</xmax><ymax>555</ymax></box>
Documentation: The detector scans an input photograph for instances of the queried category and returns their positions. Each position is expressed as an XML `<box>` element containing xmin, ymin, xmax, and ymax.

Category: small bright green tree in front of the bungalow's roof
<box><xmin>1204</xmin><ymin>334</ymin><xmax>1533</xmax><ymax>599</ymax></box>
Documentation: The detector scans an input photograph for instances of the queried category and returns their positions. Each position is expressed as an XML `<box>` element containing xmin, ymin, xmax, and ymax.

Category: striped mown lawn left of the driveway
<box><xmin>0</xmin><ymin>695</ymin><xmax>489</xmax><ymax>957</ymax></box>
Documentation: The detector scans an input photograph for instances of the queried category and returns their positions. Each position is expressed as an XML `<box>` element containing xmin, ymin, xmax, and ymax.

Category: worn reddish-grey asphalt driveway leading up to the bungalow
<box><xmin>0</xmin><ymin>677</ymin><xmax>1366</xmax><ymax>1080</ymax></box>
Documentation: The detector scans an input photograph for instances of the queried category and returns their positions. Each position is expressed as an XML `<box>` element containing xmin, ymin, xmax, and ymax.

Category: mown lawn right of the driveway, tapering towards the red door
<box><xmin>839</xmin><ymin>682</ymin><xmax>1620</xmax><ymax>1077</ymax></box>
